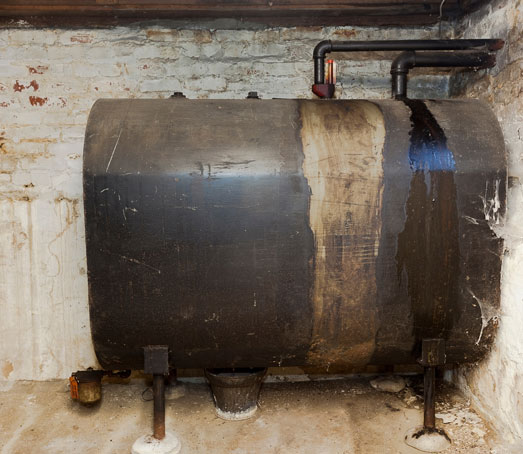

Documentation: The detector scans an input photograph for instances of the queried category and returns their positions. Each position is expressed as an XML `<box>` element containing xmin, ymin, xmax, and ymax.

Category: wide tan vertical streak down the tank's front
<box><xmin>301</xmin><ymin>101</ymin><xmax>385</xmax><ymax>365</ymax></box>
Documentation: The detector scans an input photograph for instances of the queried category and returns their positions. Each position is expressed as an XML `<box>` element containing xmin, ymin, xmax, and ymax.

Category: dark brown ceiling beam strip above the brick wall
<box><xmin>0</xmin><ymin>0</ymin><xmax>489</xmax><ymax>27</ymax></box>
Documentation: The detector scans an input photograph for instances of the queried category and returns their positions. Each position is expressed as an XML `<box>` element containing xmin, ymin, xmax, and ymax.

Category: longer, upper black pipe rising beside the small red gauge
<box><xmin>313</xmin><ymin>39</ymin><xmax>504</xmax><ymax>84</ymax></box>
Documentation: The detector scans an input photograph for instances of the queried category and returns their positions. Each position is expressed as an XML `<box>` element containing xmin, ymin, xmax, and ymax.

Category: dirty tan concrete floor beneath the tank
<box><xmin>0</xmin><ymin>377</ymin><xmax>504</xmax><ymax>454</ymax></box>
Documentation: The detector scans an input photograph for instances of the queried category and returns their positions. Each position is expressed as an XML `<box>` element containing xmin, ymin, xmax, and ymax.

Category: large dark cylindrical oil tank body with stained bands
<box><xmin>84</xmin><ymin>99</ymin><xmax>506</xmax><ymax>369</ymax></box>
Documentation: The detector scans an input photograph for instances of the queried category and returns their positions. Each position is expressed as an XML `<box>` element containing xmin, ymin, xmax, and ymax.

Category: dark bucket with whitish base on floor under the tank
<box><xmin>205</xmin><ymin>367</ymin><xmax>267</xmax><ymax>421</ymax></box>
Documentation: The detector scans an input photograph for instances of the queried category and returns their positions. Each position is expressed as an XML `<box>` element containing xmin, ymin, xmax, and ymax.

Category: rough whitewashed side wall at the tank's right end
<box><xmin>451</xmin><ymin>0</ymin><xmax>523</xmax><ymax>446</ymax></box>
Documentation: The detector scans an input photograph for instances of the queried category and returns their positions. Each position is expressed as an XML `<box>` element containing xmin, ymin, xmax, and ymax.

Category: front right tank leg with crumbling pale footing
<box><xmin>405</xmin><ymin>339</ymin><xmax>451</xmax><ymax>452</ymax></box>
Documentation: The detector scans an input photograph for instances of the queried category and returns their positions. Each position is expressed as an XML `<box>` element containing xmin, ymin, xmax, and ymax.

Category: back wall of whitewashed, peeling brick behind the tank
<box><xmin>0</xmin><ymin>23</ymin><xmax>448</xmax><ymax>380</ymax></box>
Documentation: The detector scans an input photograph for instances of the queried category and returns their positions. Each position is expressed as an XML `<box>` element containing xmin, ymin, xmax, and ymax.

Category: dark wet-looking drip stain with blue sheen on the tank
<box><xmin>396</xmin><ymin>99</ymin><xmax>460</xmax><ymax>348</ymax></box>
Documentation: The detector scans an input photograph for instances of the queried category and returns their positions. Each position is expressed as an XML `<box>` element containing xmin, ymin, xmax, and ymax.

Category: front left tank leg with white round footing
<box><xmin>131</xmin><ymin>345</ymin><xmax>182</xmax><ymax>454</ymax></box>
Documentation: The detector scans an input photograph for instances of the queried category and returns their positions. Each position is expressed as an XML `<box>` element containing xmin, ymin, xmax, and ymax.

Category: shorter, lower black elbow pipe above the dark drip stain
<box><xmin>390</xmin><ymin>51</ymin><xmax>496</xmax><ymax>98</ymax></box>
